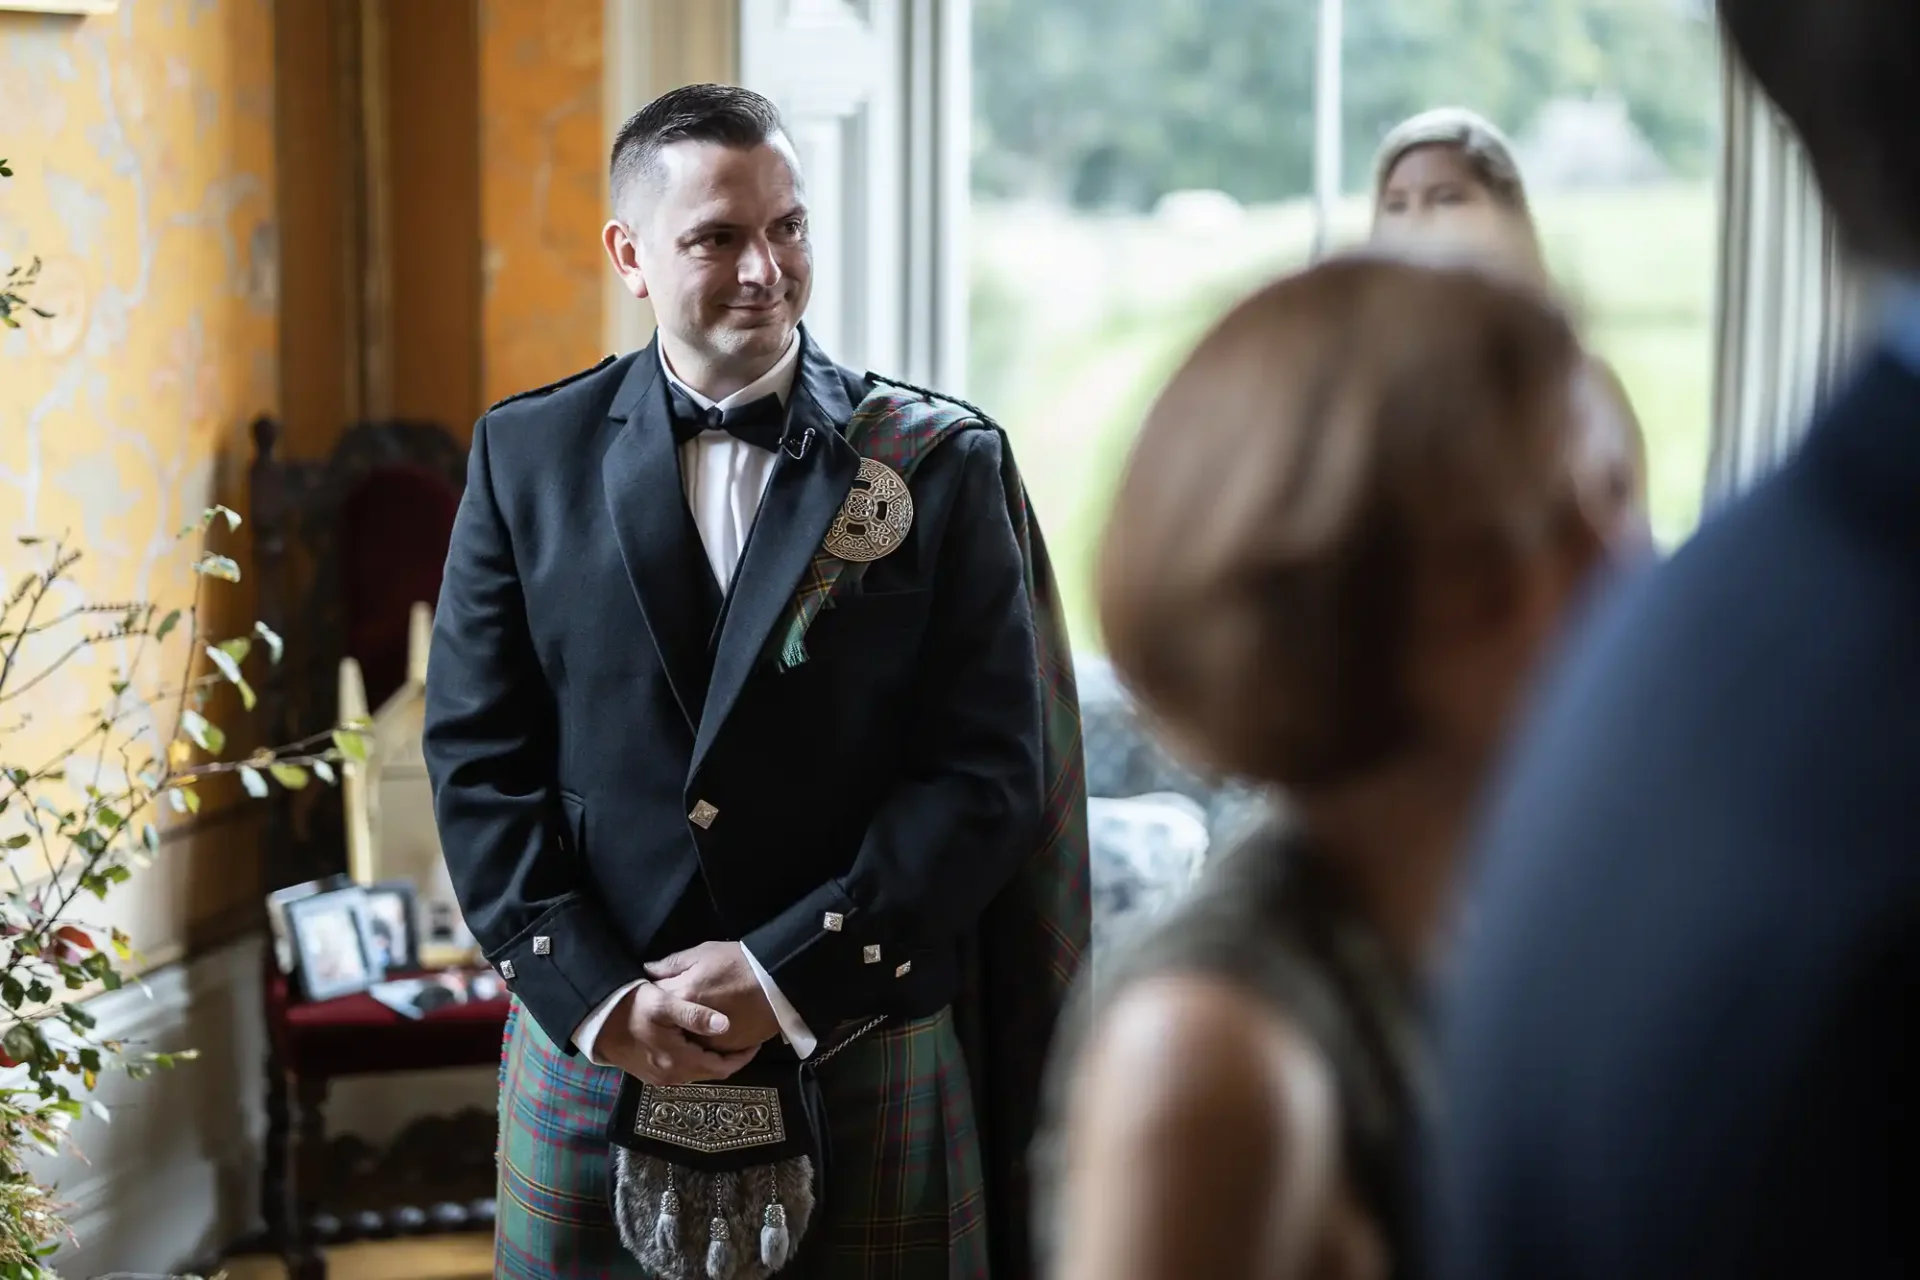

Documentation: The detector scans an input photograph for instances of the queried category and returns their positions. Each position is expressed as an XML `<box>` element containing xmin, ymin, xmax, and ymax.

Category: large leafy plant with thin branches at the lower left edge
<box><xmin>0</xmin><ymin>507</ymin><xmax>367</xmax><ymax>1280</ymax></box>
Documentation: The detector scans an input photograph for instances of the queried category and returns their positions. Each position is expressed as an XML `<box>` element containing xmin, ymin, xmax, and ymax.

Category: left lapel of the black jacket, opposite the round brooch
<box><xmin>601</xmin><ymin>344</ymin><xmax>720</xmax><ymax>729</ymax></box>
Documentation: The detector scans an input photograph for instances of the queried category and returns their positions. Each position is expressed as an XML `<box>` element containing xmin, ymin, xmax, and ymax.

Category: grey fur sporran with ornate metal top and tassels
<box><xmin>607</xmin><ymin>1017</ymin><xmax>883</xmax><ymax>1280</ymax></box>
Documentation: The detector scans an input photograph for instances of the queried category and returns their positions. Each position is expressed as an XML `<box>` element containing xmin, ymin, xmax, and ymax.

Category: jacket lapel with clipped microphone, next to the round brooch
<box><xmin>693</xmin><ymin>330</ymin><xmax>860</xmax><ymax>770</ymax></box>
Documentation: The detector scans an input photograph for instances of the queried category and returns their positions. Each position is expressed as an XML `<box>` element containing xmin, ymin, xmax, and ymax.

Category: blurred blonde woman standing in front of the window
<box><xmin>1371</xmin><ymin>107</ymin><xmax>1647</xmax><ymax>537</ymax></box>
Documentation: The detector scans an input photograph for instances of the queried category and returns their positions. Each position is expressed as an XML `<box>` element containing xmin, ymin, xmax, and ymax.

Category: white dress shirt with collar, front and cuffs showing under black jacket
<box><xmin>574</xmin><ymin>330</ymin><xmax>818</xmax><ymax>1067</ymax></box>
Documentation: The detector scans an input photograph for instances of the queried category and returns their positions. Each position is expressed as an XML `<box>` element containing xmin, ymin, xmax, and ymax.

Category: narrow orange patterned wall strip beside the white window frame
<box><xmin>480</xmin><ymin>0</ymin><xmax>609</xmax><ymax>405</ymax></box>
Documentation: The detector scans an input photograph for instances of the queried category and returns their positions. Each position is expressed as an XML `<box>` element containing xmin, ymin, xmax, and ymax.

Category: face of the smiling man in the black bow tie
<box><xmin>609</xmin><ymin>138</ymin><xmax>812</xmax><ymax>376</ymax></box>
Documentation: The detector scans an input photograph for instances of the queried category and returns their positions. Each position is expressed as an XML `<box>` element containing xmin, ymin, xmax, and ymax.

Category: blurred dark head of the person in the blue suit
<box><xmin>1718</xmin><ymin>0</ymin><xmax>1920</xmax><ymax>271</ymax></box>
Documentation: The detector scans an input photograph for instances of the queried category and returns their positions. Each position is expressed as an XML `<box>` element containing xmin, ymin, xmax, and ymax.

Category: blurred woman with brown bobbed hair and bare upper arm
<box><xmin>1035</xmin><ymin>257</ymin><xmax>1634</xmax><ymax>1280</ymax></box>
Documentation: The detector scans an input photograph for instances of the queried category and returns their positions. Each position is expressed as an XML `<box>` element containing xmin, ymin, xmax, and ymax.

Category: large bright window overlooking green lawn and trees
<box><xmin>968</xmin><ymin>0</ymin><xmax>1718</xmax><ymax>649</ymax></box>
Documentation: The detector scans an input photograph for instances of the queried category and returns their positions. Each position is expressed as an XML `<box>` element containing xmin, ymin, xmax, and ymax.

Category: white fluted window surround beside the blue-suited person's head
<box><xmin>1707</xmin><ymin>50</ymin><xmax>1872</xmax><ymax>505</ymax></box>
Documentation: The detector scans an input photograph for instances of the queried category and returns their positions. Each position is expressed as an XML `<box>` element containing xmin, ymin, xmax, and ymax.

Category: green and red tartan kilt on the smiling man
<box><xmin>493</xmin><ymin>1000</ymin><xmax>989</xmax><ymax>1280</ymax></box>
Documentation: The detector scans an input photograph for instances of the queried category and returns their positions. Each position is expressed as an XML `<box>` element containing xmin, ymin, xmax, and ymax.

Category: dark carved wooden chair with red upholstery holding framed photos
<box><xmin>250</xmin><ymin>418</ymin><xmax>507</xmax><ymax>1280</ymax></box>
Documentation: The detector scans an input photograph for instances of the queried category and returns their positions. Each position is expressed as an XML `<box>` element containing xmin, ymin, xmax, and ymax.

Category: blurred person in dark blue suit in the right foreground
<box><xmin>1430</xmin><ymin>0</ymin><xmax>1920</xmax><ymax>1280</ymax></box>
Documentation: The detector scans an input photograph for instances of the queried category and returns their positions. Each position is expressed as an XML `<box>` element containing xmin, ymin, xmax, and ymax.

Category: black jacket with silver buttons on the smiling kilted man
<box><xmin>424</xmin><ymin>334</ymin><xmax>1043</xmax><ymax>1052</ymax></box>
